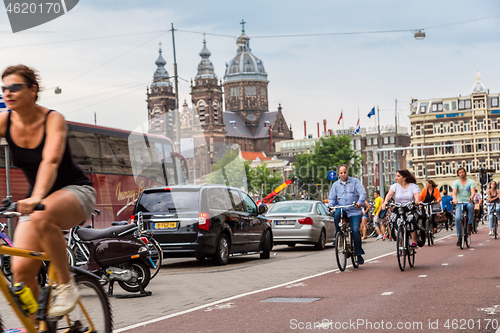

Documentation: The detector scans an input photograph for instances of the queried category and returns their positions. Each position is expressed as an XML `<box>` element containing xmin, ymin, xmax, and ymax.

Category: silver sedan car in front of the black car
<box><xmin>265</xmin><ymin>200</ymin><xmax>335</xmax><ymax>250</ymax></box>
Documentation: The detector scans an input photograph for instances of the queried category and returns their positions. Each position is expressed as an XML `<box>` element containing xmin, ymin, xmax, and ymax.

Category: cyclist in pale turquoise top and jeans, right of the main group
<box><xmin>452</xmin><ymin>167</ymin><xmax>476</xmax><ymax>246</ymax></box>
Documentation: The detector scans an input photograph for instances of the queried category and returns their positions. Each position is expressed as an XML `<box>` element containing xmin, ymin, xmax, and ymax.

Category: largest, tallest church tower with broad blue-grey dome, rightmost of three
<box><xmin>223</xmin><ymin>21</ymin><xmax>269</xmax><ymax>134</ymax></box>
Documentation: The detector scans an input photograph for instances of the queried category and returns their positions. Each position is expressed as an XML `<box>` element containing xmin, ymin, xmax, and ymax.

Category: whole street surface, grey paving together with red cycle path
<box><xmin>0</xmin><ymin>224</ymin><xmax>500</xmax><ymax>332</ymax></box>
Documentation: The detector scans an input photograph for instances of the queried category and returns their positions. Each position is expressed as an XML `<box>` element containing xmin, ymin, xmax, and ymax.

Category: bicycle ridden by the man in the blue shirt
<box><xmin>332</xmin><ymin>202</ymin><xmax>359</xmax><ymax>272</ymax></box>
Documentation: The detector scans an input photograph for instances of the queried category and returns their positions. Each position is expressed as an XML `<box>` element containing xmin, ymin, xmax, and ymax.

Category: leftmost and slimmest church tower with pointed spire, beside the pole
<box><xmin>146</xmin><ymin>43</ymin><xmax>175</xmax><ymax>140</ymax></box>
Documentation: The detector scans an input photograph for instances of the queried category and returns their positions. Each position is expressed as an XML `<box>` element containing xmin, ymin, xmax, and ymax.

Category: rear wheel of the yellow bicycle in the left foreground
<box><xmin>48</xmin><ymin>274</ymin><xmax>113</xmax><ymax>333</ymax></box>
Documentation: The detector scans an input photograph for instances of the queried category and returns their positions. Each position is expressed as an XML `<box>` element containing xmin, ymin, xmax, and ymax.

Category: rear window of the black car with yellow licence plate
<box><xmin>137</xmin><ymin>189</ymin><xmax>200</xmax><ymax>212</ymax></box>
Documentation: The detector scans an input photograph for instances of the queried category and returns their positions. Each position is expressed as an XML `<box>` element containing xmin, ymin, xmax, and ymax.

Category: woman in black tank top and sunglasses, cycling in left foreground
<box><xmin>0</xmin><ymin>65</ymin><xmax>96</xmax><ymax>316</ymax></box>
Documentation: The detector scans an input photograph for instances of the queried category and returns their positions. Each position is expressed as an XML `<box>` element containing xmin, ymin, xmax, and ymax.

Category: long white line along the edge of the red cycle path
<box><xmin>114</xmin><ymin>231</ymin><xmax>454</xmax><ymax>333</ymax></box>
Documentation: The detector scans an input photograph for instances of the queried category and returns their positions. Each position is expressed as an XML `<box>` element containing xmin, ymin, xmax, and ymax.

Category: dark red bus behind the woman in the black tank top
<box><xmin>0</xmin><ymin>122</ymin><xmax>188</xmax><ymax>228</ymax></box>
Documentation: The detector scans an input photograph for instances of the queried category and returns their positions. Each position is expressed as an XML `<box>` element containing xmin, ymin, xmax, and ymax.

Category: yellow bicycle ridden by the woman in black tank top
<box><xmin>0</xmin><ymin>203</ymin><xmax>113</xmax><ymax>333</ymax></box>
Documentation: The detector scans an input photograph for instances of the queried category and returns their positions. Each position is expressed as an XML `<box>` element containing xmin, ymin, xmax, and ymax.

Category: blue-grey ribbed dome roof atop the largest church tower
<box><xmin>224</xmin><ymin>32</ymin><xmax>267</xmax><ymax>82</ymax></box>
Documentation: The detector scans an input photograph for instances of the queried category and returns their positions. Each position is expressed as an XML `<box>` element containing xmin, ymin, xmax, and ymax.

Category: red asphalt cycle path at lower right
<box><xmin>125</xmin><ymin>228</ymin><xmax>500</xmax><ymax>333</ymax></box>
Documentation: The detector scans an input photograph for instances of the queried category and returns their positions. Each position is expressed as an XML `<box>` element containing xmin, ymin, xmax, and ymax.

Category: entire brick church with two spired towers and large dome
<box><xmin>147</xmin><ymin>24</ymin><xmax>293</xmax><ymax>154</ymax></box>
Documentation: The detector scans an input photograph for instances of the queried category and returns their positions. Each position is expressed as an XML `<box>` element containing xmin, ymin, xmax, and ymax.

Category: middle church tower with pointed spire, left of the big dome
<box><xmin>191</xmin><ymin>39</ymin><xmax>226</xmax><ymax>148</ymax></box>
